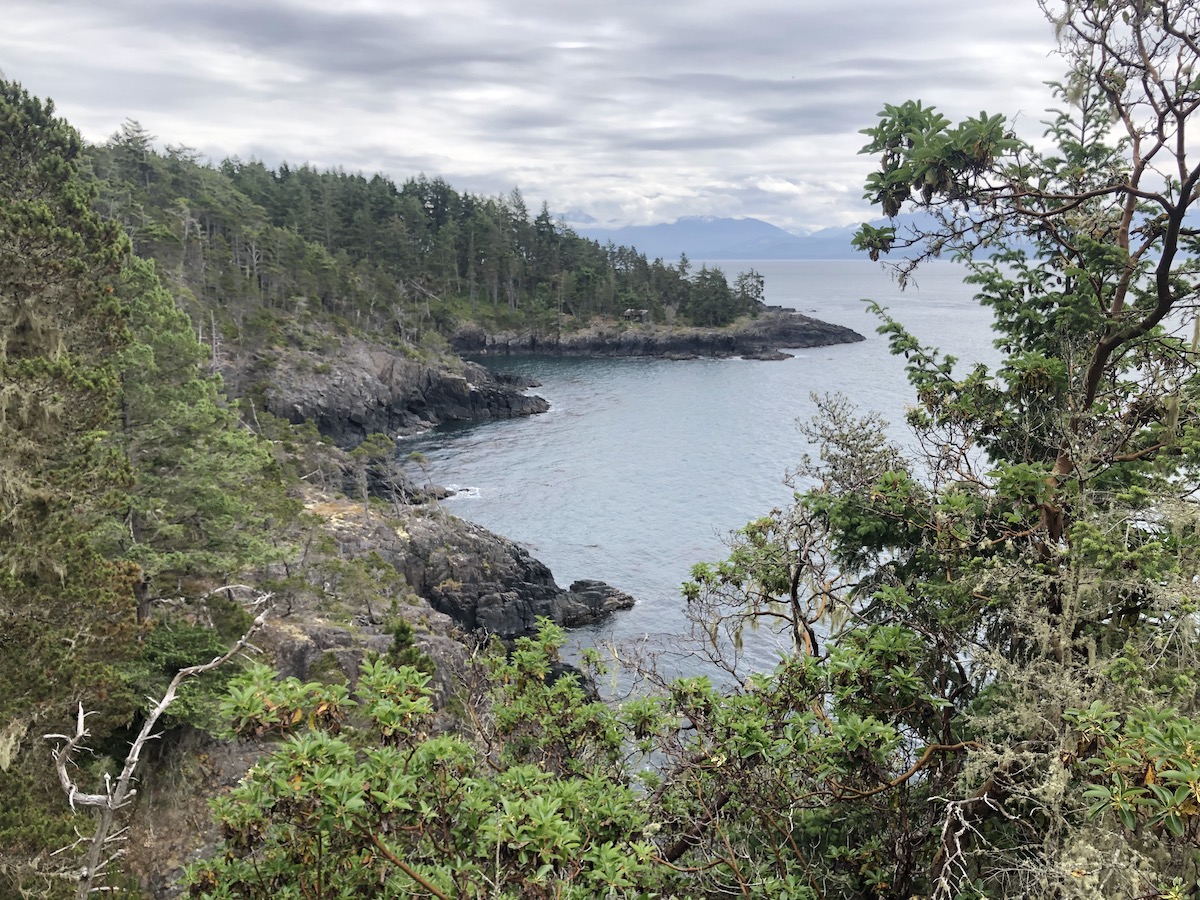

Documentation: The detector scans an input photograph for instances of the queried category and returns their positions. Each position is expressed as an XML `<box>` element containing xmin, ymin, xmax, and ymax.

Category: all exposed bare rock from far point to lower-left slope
<box><xmin>117</xmin><ymin>314</ymin><xmax>863</xmax><ymax>898</ymax></box>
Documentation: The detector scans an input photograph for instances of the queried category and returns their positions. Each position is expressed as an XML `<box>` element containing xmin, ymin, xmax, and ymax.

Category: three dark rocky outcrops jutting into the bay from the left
<box><xmin>199</xmin><ymin>310</ymin><xmax>864</xmax><ymax>640</ymax></box>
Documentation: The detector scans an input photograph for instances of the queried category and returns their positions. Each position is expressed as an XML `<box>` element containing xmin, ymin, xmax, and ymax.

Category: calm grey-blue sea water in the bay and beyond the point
<box><xmin>401</xmin><ymin>262</ymin><xmax>996</xmax><ymax>666</ymax></box>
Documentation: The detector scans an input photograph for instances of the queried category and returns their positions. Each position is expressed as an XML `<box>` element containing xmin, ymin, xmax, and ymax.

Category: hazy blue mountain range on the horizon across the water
<box><xmin>572</xmin><ymin>216</ymin><xmax>866</xmax><ymax>262</ymax></box>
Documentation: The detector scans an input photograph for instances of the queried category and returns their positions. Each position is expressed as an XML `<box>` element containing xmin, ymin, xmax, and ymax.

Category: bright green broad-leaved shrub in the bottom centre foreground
<box><xmin>187</xmin><ymin>626</ymin><xmax>667</xmax><ymax>900</ymax></box>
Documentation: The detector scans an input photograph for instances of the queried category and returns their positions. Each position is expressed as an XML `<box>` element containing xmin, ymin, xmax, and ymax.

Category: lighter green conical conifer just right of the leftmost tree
<box><xmin>108</xmin><ymin>259</ymin><xmax>295</xmax><ymax>619</ymax></box>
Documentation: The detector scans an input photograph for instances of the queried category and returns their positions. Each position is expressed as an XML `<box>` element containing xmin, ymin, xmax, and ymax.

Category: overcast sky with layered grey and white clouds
<box><xmin>0</xmin><ymin>0</ymin><xmax>1062</xmax><ymax>229</ymax></box>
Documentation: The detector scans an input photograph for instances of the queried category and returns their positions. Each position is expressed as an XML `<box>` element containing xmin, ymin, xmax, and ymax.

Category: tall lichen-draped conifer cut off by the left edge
<box><xmin>0</xmin><ymin>82</ymin><xmax>134</xmax><ymax>895</ymax></box>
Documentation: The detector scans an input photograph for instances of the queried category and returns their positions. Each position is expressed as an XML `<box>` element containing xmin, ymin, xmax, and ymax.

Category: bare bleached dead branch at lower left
<box><xmin>43</xmin><ymin>588</ymin><xmax>270</xmax><ymax>900</ymax></box>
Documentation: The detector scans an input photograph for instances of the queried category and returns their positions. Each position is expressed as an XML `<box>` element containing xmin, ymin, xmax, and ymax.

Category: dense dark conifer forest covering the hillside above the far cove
<box><xmin>88</xmin><ymin>127</ymin><xmax>762</xmax><ymax>349</ymax></box>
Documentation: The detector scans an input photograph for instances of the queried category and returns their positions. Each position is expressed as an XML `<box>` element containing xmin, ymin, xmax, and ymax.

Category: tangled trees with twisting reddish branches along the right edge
<box><xmin>694</xmin><ymin>2</ymin><xmax>1200</xmax><ymax>898</ymax></box>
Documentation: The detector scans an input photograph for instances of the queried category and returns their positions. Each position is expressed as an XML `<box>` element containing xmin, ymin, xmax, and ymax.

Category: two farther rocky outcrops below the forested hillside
<box><xmin>221</xmin><ymin>310</ymin><xmax>864</xmax><ymax>448</ymax></box>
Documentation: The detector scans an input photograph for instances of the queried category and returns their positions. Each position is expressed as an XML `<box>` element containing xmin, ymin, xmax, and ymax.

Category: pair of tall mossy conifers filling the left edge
<box><xmin>0</xmin><ymin>80</ymin><xmax>289</xmax><ymax>896</ymax></box>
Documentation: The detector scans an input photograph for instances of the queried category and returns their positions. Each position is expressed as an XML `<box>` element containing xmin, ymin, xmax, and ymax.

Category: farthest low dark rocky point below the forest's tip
<box><xmin>450</xmin><ymin>311</ymin><xmax>864</xmax><ymax>359</ymax></box>
